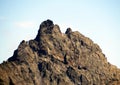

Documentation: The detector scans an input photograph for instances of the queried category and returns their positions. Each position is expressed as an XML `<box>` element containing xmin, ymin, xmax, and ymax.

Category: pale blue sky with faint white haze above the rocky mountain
<box><xmin>0</xmin><ymin>0</ymin><xmax>120</xmax><ymax>68</ymax></box>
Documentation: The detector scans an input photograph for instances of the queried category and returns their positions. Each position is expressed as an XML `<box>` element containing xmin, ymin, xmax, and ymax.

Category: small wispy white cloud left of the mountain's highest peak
<box><xmin>14</xmin><ymin>21</ymin><xmax>35</xmax><ymax>28</ymax></box>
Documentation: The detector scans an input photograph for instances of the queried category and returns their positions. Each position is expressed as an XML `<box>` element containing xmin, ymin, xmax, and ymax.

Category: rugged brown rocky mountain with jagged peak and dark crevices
<box><xmin>0</xmin><ymin>20</ymin><xmax>120</xmax><ymax>85</ymax></box>
